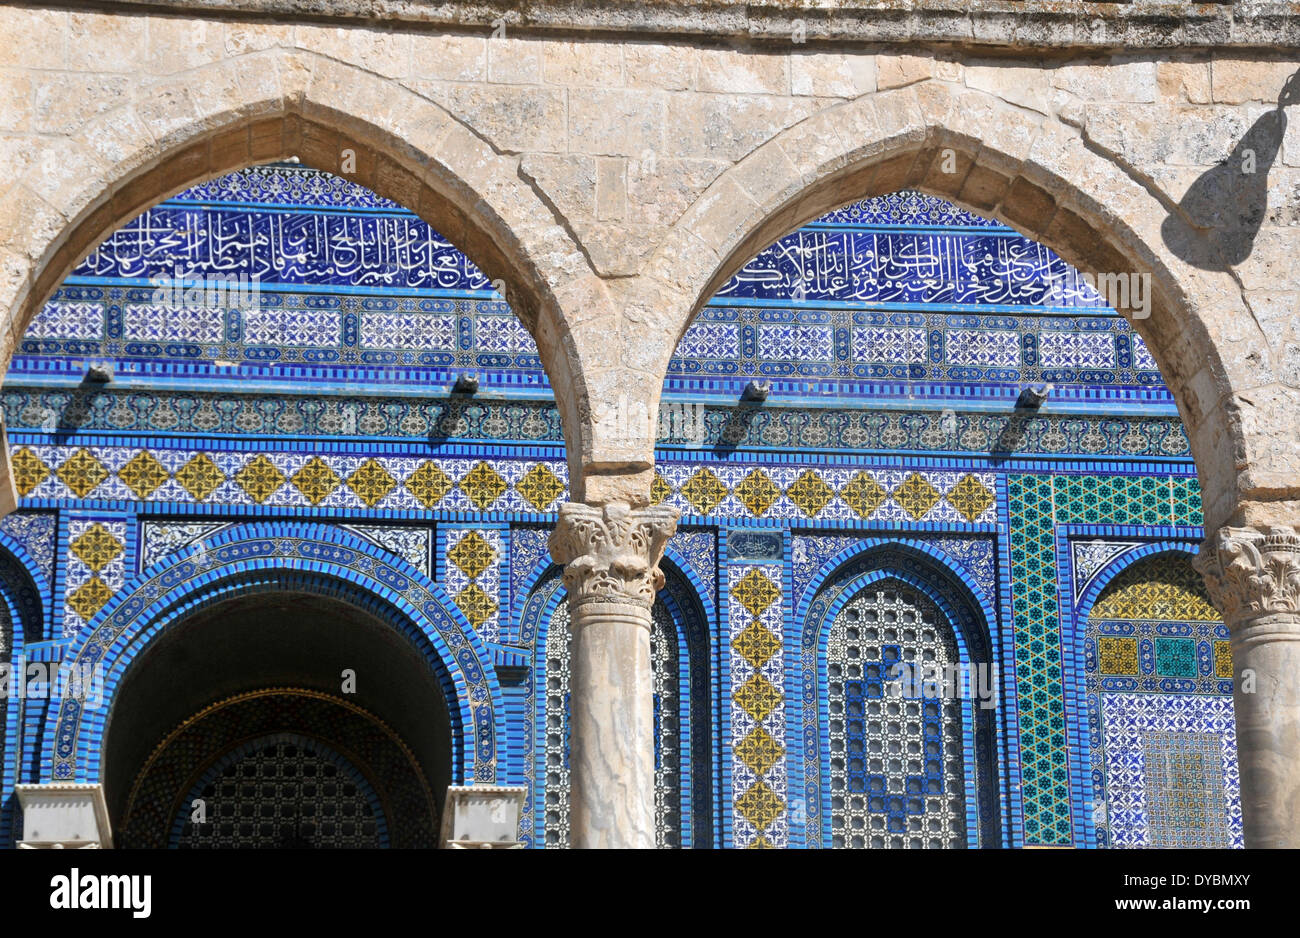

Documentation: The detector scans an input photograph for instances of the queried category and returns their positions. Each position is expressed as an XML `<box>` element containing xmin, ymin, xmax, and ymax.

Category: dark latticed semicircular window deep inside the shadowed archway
<box><xmin>177</xmin><ymin>734</ymin><xmax>385</xmax><ymax>850</ymax></box>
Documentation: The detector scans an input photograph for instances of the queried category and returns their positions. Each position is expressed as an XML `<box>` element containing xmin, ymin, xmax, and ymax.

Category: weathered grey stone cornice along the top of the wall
<box><xmin>30</xmin><ymin>0</ymin><xmax>1300</xmax><ymax>53</ymax></box>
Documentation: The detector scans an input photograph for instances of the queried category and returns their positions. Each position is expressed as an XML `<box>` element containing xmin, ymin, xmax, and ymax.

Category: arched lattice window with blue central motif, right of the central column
<box><xmin>827</xmin><ymin>579</ymin><xmax>966</xmax><ymax>847</ymax></box>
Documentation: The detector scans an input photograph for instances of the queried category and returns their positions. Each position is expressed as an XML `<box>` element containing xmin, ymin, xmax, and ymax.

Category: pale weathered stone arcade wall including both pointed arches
<box><xmin>0</xmin><ymin>18</ymin><xmax>1300</xmax><ymax>847</ymax></box>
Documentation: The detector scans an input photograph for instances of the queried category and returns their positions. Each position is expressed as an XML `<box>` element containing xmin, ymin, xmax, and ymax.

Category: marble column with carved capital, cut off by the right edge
<box><xmin>1196</xmin><ymin>525</ymin><xmax>1300</xmax><ymax>847</ymax></box>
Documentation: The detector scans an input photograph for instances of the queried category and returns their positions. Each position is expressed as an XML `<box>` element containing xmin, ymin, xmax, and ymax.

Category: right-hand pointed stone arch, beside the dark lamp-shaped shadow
<box><xmin>641</xmin><ymin>81</ymin><xmax>1279</xmax><ymax>527</ymax></box>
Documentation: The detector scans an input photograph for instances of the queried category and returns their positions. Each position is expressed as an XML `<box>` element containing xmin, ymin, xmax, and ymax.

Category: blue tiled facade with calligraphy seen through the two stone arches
<box><xmin>0</xmin><ymin>164</ymin><xmax>1242</xmax><ymax>848</ymax></box>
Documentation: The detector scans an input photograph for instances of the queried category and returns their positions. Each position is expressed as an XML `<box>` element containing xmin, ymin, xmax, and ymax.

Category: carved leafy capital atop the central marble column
<box><xmin>550</xmin><ymin>501</ymin><xmax>677</xmax><ymax>609</ymax></box>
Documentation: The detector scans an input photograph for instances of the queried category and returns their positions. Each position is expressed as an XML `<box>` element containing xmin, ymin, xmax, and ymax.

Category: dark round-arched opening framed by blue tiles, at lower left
<box><xmin>103</xmin><ymin>591</ymin><xmax>452</xmax><ymax>847</ymax></box>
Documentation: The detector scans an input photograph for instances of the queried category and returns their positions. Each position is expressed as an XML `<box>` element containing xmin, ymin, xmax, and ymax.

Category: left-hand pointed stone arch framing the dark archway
<box><xmin>0</xmin><ymin>48</ymin><xmax>590</xmax><ymax>504</ymax></box>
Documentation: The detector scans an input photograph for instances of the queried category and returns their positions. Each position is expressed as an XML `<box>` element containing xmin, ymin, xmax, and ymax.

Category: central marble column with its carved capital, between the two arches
<box><xmin>550</xmin><ymin>501</ymin><xmax>677</xmax><ymax>848</ymax></box>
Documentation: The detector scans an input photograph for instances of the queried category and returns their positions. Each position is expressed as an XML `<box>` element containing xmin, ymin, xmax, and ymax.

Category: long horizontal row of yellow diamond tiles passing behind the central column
<box><xmin>12</xmin><ymin>446</ymin><xmax>996</xmax><ymax>522</ymax></box>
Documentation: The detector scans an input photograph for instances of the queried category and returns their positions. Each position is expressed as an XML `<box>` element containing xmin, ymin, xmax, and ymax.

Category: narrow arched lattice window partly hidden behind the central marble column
<box><xmin>545</xmin><ymin>602</ymin><xmax>681</xmax><ymax>847</ymax></box>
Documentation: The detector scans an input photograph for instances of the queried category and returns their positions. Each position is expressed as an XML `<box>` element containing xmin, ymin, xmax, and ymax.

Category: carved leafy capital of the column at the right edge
<box><xmin>1193</xmin><ymin>525</ymin><xmax>1300</xmax><ymax>625</ymax></box>
